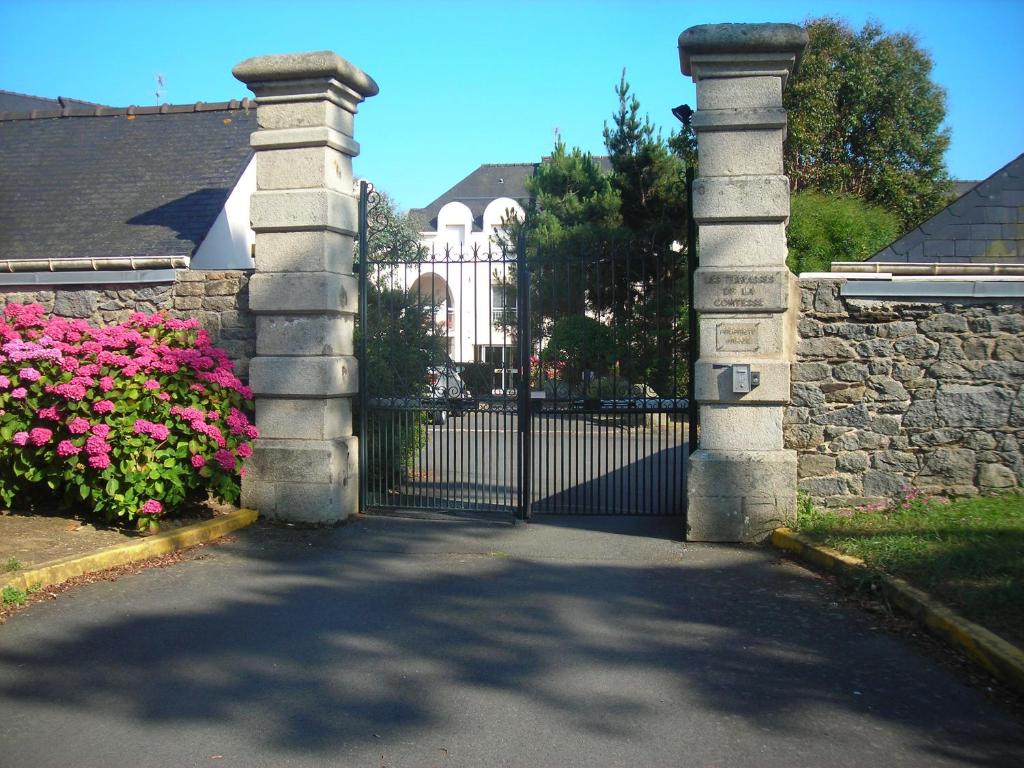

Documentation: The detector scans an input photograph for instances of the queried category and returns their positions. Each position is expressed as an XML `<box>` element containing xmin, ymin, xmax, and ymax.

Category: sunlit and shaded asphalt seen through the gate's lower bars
<box><xmin>372</xmin><ymin>412</ymin><xmax>686</xmax><ymax>515</ymax></box>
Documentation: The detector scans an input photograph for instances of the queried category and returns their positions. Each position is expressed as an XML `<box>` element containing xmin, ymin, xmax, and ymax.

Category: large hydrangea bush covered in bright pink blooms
<box><xmin>0</xmin><ymin>304</ymin><xmax>257</xmax><ymax>527</ymax></box>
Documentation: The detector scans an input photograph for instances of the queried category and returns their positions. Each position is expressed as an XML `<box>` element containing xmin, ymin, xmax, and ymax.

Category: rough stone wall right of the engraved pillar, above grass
<box><xmin>784</xmin><ymin>280</ymin><xmax>1024</xmax><ymax>506</ymax></box>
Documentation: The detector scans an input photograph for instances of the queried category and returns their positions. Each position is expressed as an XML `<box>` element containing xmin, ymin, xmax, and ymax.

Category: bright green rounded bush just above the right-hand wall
<box><xmin>786</xmin><ymin>190</ymin><xmax>900</xmax><ymax>274</ymax></box>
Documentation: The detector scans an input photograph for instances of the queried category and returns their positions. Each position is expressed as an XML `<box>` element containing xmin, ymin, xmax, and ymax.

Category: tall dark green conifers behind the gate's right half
<box><xmin>509</xmin><ymin>73</ymin><xmax>695</xmax><ymax>393</ymax></box>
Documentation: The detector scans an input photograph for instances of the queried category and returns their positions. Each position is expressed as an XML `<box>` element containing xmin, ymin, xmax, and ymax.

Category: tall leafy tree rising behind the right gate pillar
<box><xmin>783</xmin><ymin>17</ymin><xmax>951</xmax><ymax>228</ymax></box>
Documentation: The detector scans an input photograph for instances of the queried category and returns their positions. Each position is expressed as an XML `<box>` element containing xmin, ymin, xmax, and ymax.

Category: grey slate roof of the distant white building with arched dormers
<box><xmin>409</xmin><ymin>157</ymin><xmax>611</xmax><ymax>231</ymax></box>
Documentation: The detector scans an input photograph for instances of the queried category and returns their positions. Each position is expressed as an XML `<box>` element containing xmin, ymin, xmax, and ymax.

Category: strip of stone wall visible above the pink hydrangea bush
<box><xmin>0</xmin><ymin>269</ymin><xmax>256</xmax><ymax>379</ymax></box>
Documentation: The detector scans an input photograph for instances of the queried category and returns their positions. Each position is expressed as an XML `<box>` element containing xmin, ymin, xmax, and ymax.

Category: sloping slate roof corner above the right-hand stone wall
<box><xmin>867</xmin><ymin>155</ymin><xmax>1024</xmax><ymax>263</ymax></box>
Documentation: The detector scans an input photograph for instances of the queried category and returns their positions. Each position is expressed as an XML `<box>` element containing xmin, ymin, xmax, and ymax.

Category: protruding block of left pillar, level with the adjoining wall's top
<box><xmin>249</xmin><ymin>272</ymin><xmax>359</xmax><ymax>314</ymax></box>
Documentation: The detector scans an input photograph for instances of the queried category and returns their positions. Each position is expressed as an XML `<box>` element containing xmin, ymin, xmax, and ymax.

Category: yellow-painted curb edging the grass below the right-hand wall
<box><xmin>771</xmin><ymin>528</ymin><xmax>1024</xmax><ymax>693</ymax></box>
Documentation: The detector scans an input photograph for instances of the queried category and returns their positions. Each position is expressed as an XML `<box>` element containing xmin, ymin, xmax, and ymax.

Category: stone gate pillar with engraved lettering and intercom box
<box><xmin>679</xmin><ymin>24</ymin><xmax>807</xmax><ymax>542</ymax></box>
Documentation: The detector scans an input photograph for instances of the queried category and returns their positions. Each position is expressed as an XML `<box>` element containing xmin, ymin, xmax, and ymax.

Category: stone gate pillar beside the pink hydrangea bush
<box><xmin>232</xmin><ymin>51</ymin><xmax>378</xmax><ymax>522</ymax></box>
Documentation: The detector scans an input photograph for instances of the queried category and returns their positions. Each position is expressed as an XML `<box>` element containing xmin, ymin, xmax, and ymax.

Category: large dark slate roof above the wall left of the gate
<box><xmin>0</xmin><ymin>100</ymin><xmax>256</xmax><ymax>260</ymax></box>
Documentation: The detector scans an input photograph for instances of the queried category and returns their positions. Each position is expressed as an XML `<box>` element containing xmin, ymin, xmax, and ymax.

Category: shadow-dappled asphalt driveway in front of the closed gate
<box><xmin>0</xmin><ymin>517</ymin><xmax>1024</xmax><ymax>768</ymax></box>
